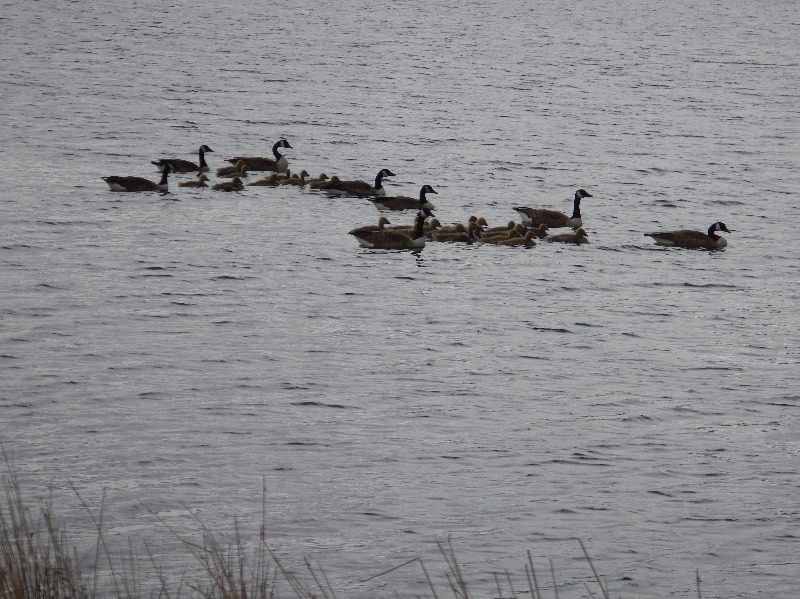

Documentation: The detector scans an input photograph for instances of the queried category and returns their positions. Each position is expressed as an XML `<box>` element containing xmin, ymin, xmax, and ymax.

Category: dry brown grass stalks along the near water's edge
<box><xmin>0</xmin><ymin>464</ymin><xmax>701</xmax><ymax>599</ymax></box>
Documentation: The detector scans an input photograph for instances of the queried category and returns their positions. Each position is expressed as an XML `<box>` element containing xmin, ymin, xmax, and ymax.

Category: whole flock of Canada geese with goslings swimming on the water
<box><xmin>102</xmin><ymin>138</ymin><xmax>731</xmax><ymax>250</ymax></box>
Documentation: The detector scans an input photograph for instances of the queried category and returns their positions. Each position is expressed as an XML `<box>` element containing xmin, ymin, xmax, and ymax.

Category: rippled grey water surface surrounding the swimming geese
<box><xmin>0</xmin><ymin>0</ymin><xmax>800</xmax><ymax>597</ymax></box>
